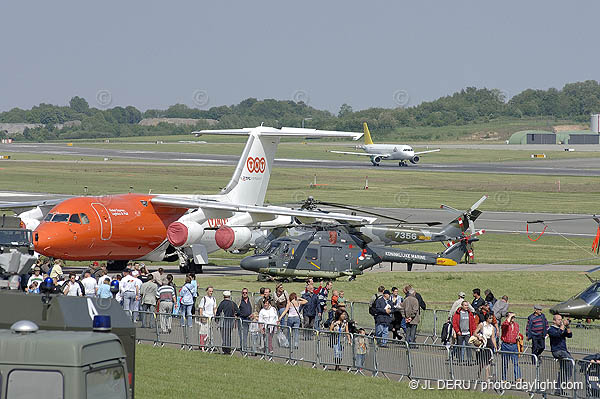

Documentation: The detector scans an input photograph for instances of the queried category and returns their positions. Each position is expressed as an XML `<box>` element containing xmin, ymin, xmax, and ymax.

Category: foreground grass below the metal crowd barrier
<box><xmin>135</xmin><ymin>345</ymin><xmax>506</xmax><ymax>399</ymax></box>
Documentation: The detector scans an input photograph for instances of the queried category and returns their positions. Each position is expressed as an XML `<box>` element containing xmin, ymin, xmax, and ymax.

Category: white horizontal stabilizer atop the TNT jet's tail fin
<box><xmin>192</xmin><ymin>126</ymin><xmax>363</xmax><ymax>140</ymax></box>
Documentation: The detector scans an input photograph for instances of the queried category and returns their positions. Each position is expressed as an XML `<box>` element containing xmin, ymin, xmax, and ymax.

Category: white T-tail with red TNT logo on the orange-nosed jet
<box><xmin>194</xmin><ymin>126</ymin><xmax>362</xmax><ymax>206</ymax></box>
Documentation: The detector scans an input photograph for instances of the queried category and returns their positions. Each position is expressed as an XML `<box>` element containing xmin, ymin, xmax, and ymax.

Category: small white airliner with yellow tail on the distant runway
<box><xmin>329</xmin><ymin>122</ymin><xmax>439</xmax><ymax>166</ymax></box>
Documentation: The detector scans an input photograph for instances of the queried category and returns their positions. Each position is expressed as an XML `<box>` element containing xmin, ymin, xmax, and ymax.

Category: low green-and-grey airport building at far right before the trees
<box><xmin>507</xmin><ymin>114</ymin><xmax>600</xmax><ymax>144</ymax></box>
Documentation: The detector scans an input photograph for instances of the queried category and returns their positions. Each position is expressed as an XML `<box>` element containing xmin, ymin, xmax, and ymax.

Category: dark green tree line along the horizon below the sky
<box><xmin>0</xmin><ymin>80</ymin><xmax>600</xmax><ymax>141</ymax></box>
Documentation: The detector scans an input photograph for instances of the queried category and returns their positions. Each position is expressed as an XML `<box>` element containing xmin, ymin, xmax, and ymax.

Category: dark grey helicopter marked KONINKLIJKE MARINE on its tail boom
<box><xmin>240</xmin><ymin>225</ymin><xmax>479</xmax><ymax>280</ymax></box>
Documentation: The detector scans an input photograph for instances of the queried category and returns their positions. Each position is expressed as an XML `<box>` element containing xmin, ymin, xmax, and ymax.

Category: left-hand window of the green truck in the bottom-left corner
<box><xmin>6</xmin><ymin>370</ymin><xmax>64</xmax><ymax>399</ymax></box>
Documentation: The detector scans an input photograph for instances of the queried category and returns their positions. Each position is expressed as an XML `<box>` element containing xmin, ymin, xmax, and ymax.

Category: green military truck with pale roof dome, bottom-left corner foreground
<box><xmin>0</xmin><ymin>321</ymin><xmax>133</xmax><ymax>399</ymax></box>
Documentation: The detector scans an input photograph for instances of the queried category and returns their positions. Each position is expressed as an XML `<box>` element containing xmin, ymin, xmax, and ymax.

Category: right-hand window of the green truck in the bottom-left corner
<box><xmin>85</xmin><ymin>365</ymin><xmax>127</xmax><ymax>399</ymax></box>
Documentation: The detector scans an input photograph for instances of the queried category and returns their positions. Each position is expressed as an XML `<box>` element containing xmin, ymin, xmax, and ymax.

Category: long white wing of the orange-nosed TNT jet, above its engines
<box><xmin>150</xmin><ymin>195</ymin><xmax>371</xmax><ymax>223</ymax></box>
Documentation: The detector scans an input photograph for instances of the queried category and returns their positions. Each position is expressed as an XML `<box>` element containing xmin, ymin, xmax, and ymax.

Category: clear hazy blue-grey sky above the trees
<box><xmin>0</xmin><ymin>0</ymin><xmax>600</xmax><ymax>112</ymax></box>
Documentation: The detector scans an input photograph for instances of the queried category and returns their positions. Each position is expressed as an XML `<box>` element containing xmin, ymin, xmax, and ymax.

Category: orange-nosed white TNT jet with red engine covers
<box><xmin>2</xmin><ymin>126</ymin><xmax>370</xmax><ymax>272</ymax></box>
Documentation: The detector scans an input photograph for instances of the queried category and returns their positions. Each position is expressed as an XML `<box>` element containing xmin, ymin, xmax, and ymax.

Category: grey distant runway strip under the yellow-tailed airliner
<box><xmin>0</xmin><ymin>143</ymin><xmax>600</xmax><ymax>176</ymax></box>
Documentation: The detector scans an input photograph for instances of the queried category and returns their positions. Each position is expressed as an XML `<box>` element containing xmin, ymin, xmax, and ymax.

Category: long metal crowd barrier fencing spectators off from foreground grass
<box><xmin>135</xmin><ymin>312</ymin><xmax>600</xmax><ymax>398</ymax></box>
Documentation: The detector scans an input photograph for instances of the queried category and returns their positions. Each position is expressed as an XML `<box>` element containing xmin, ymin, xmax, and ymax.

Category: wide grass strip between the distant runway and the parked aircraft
<box><xmin>0</xmin><ymin>156</ymin><xmax>600</xmax><ymax>213</ymax></box>
